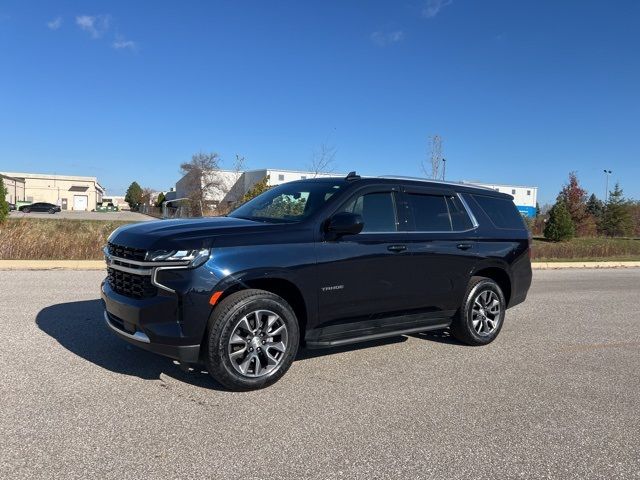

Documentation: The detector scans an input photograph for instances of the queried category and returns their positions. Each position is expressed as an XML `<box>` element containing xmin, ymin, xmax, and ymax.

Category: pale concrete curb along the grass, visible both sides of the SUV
<box><xmin>0</xmin><ymin>260</ymin><xmax>640</xmax><ymax>270</ymax></box>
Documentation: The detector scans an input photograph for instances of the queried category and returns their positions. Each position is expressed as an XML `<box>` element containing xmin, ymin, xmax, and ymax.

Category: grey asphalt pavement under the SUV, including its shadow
<box><xmin>0</xmin><ymin>269</ymin><xmax>640</xmax><ymax>479</ymax></box>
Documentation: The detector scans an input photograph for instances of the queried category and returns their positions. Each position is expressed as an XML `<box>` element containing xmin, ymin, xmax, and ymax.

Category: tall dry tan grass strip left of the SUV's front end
<box><xmin>0</xmin><ymin>218</ymin><xmax>130</xmax><ymax>260</ymax></box>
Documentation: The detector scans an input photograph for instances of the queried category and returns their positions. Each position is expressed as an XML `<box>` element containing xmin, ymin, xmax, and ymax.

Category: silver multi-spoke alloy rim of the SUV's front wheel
<box><xmin>228</xmin><ymin>310</ymin><xmax>288</xmax><ymax>378</ymax></box>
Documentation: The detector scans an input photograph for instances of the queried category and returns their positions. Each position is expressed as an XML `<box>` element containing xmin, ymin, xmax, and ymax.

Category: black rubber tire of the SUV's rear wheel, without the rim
<box><xmin>451</xmin><ymin>277</ymin><xmax>507</xmax><ymax>346</ymax></box>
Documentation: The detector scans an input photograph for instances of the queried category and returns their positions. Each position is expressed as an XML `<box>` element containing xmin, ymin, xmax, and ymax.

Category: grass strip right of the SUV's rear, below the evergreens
<box><xmin>531</xmin><ymin>237</ymin><xmax>640</xmax><ymax>262</ymax></box>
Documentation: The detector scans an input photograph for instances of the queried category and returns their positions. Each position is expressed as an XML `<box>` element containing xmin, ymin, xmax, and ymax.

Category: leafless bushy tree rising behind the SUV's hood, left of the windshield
<box><xmin>180</xmin><ymin>152</ymin><xmax>224</xmax><ymax>216</ymax></box>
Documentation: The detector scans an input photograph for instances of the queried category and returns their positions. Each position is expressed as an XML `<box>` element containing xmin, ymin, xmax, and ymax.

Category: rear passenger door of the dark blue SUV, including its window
<box><xmin>401</xmin><ymin>186</ymin><xmax>478</xmax><ymax>315</ymax></box>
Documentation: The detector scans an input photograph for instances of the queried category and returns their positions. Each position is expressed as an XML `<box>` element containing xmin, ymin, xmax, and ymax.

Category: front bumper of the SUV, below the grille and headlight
<box><xmin>100</xmin><ymin>282</ymin><xmax>202</xmax><ymax>363</ymax></box>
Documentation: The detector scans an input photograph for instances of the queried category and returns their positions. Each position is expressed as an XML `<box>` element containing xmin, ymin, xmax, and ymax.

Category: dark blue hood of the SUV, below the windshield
<box><xmin>109</xmin><ymin>217</ymin><xmax>282</xmax><ymax>250</ymax></box>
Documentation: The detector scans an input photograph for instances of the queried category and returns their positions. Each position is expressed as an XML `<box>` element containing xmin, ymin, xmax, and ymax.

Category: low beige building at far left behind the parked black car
<box><xmin>0</xmin><ymin>172</ymin><xmax>105</xmax><ymax>210</ymax></box>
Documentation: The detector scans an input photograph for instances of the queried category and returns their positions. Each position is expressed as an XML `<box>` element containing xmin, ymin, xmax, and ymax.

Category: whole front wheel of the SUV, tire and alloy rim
<box><xmin>206</xmin><ymin>289</ymin><xmax>300</xmax><ymax>391</ymax></box>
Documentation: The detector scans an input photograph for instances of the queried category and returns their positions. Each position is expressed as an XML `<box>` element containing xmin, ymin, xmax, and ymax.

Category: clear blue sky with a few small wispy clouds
<box><xmin>0</xmin><ymin>0</ymin><xmax>640</xmax><ymax>203</ymax></box>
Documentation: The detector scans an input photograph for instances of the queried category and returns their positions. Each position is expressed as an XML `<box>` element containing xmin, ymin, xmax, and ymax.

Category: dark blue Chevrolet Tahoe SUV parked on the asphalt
<box><xmin>102</xmin><ymin>173</ymin><xmax>531</xmax><ymax>390</ymax></box>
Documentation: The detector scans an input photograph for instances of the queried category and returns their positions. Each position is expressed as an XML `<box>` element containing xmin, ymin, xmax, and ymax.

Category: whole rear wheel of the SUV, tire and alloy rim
<box><xmin>451</xmin><ymin>277</ymin><xmax>506</xmax><ymax>345</ymax></box>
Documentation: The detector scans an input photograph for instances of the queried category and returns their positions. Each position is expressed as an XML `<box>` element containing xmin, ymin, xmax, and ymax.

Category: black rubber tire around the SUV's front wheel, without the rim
<box><xmin>205</xmin><ymin>289</ymin><xmax>300</xmax><ymax>391</ymax></box>
